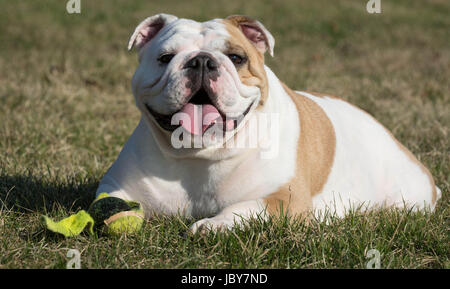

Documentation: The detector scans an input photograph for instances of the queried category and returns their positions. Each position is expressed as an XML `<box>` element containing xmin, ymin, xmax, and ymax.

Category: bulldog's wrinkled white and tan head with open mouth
<box><xmin>128</xmin><ymin>14</ymin><xmax>274</xmax><ymax>155</ymax></box>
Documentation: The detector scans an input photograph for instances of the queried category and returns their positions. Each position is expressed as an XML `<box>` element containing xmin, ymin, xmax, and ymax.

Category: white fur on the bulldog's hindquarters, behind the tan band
<box><xmin>299</xmin><ymin>92</ymin><xmax>440</xmax><ymax>216</ymax></box>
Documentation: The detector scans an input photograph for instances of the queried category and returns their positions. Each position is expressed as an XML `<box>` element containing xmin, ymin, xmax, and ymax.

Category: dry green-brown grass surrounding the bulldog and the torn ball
<box><xmin>0</xmin><ymin>0</ymin><xmax>450</xmax><ymax>268</ymax></box>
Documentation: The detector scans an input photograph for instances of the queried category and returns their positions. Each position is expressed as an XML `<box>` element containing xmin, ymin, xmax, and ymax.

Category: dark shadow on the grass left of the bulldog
<box><xmin>0</xmin><ymin>175</ymin><xmax>98</xmax><ymax>213</ymax></box>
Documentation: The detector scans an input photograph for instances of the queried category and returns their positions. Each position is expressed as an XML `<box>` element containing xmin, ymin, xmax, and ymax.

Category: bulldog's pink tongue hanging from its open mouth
<box><xmin>181</xmin><ymin>103</ymin><xmax>234</xmax><ymax>135</ymax></box>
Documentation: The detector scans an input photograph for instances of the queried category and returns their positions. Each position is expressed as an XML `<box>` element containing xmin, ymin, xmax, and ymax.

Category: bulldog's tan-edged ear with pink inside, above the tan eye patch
<box><xmin>225</xmin><ymin>15</ymin><xmax>275</xmax><ymax>56</ymax></box>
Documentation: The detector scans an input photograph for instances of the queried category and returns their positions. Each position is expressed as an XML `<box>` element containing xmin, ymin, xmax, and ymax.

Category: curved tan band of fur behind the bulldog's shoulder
<box><xmin>265</xmin><ymin>84</ymin><xmax>336</xmax><ymax>215</ymax></box>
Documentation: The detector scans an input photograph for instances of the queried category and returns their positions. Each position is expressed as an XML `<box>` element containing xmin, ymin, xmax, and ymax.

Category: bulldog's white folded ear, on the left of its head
<box><xmin>128</xmin><ymin>13</ymin><xmax>178</xmax><ymax>50</ymax></box>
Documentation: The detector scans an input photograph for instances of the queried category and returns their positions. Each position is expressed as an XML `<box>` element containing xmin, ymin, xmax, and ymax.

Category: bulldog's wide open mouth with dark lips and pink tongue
<box><xmin>145</xmin><ymin>88</ymin><xmax>253</xmax><ymax>135</ymax></box>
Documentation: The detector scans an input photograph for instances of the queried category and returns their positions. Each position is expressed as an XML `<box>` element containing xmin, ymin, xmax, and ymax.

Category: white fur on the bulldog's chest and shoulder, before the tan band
<box><xmin>97</xmin><ymin>67</ymin><xmax>299</xmax><ymax>231</ymax></box>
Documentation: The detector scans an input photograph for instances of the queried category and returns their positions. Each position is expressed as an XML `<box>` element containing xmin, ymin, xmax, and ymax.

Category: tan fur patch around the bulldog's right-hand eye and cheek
<box><xmin>223</xmin><ymin>17</ymin><xmax>268</xmax><ymax>106</ymax></box>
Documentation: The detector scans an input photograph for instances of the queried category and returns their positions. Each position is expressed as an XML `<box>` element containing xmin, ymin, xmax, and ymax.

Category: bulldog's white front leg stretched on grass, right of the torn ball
<box><xmin>189</xmin><ymin>199</ymin><xmax>266</xmax><ymax>234</ymax></box>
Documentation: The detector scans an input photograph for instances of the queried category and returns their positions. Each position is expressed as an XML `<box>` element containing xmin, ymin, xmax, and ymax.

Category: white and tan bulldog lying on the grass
<box><xmin>97</xmin><ymin>14</ymin><xmax>440</xmax><ymax>232</ymax></box>
